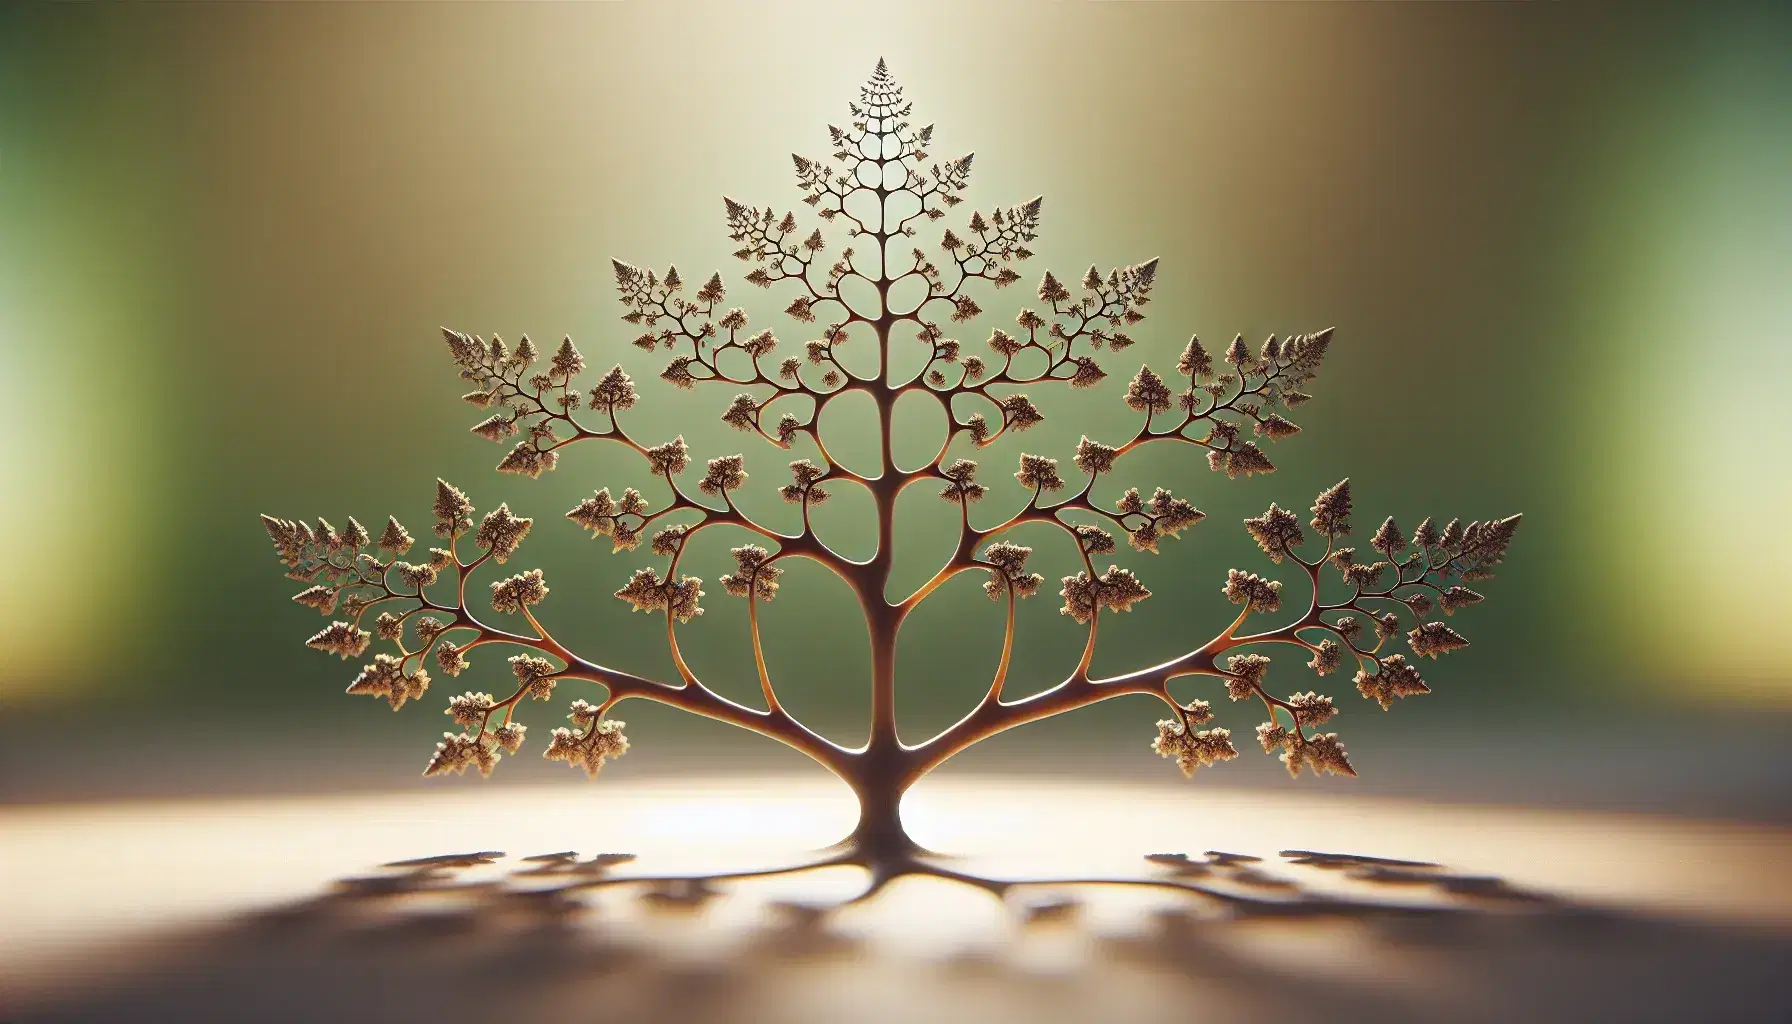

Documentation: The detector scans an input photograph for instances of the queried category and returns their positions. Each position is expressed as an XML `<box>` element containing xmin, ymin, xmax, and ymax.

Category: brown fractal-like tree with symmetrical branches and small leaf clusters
<box><xmin>263</xmin><ymin>61</ymin><xmax>1518</xmax><ymax>867</ymax></box>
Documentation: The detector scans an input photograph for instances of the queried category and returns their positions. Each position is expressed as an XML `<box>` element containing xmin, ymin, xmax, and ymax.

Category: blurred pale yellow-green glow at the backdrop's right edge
<box><xmin>1590</xmin><ymin>26</ymin><xmax>1792</xmax><ymax>699</ymax></box>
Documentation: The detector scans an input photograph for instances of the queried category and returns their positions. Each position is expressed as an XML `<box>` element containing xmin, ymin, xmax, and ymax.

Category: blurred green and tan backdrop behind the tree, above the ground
<box><xmin>0</xmin><ymin>4</ymin><xmax>1792</xmax><ymax>799</ymax></box>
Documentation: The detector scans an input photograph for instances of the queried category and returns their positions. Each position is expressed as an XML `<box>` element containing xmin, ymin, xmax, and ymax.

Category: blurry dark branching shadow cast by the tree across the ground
<box><xmin>18</xmin><ymin>850</ymin><xmax>1792</xmax><ymax>1024</ymax></box>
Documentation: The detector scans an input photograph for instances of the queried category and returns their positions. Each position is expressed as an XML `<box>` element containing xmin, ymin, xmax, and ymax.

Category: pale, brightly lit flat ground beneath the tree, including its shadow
<box><xmin>0</xmin><ymin>777</ymin><xmax>1792</xmax><ymax>1024</ymax></box>
